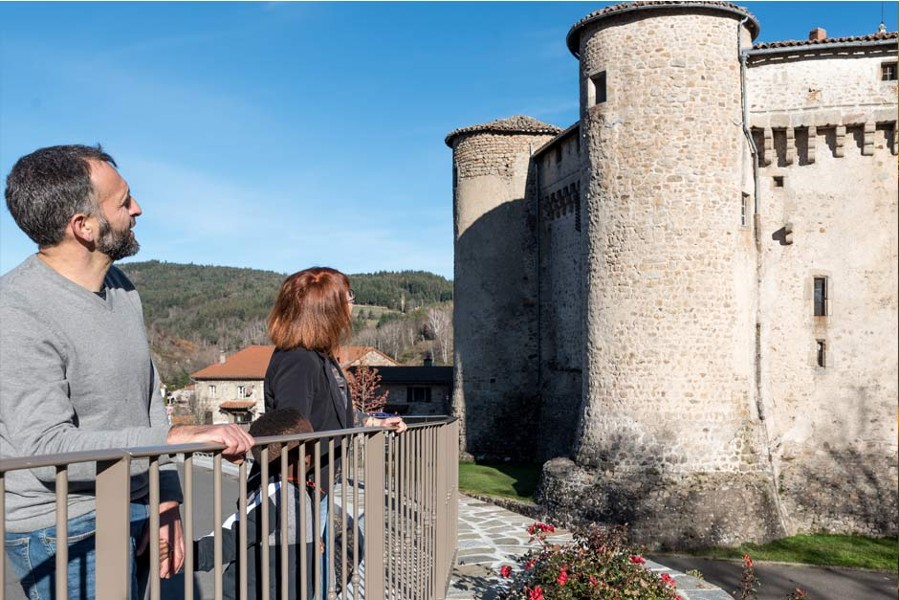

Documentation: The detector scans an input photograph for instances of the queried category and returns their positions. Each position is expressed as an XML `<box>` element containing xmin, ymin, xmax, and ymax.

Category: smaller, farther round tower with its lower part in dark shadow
<box><xmin>446</xmin><ymin>116</ymin><xmax>561</xmax><ymax>460</ymax></box>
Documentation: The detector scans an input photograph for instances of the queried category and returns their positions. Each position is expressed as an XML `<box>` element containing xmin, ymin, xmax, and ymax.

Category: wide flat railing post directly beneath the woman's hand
<box><xmin>365</xmin><ymin>431</ymin><xmax>386</xmax><ymax>600</ymax></box>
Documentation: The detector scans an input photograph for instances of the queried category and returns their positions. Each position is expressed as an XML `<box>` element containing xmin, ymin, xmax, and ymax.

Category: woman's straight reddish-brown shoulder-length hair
<box><xmin>268</xmin><ymin>267</ymin><xmax>353</xmax><ymax>354</ymax></box>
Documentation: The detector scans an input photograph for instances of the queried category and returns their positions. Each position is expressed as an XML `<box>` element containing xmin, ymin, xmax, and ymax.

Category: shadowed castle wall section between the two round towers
<box><xmin>535</xmin><ymin>128</ymin><xmax>585</xmax><ymax>462</ymax></box>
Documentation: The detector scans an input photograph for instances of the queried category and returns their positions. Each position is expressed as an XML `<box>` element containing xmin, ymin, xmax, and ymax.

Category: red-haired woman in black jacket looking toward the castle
<box><xmin>264</xmin><ymin>267</ymin><xmax>406</xmax><ymax>433</ymax></box>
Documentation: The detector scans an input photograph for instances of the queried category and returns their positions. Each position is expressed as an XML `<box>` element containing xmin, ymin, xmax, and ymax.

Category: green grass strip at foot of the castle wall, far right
<box><xmin>690</xmin><ymin>533</ymin><xmax>899</xmax><ymax>573</ymax></box>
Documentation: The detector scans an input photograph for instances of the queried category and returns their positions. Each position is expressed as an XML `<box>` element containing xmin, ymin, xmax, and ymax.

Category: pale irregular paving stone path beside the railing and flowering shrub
<box><xmin>447</xmin><ymin>495</ymin><xmax>732</xmax><ymax>600</ymax></box>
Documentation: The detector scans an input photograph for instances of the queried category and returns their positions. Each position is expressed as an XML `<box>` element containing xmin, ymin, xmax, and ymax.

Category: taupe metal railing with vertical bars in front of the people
<box><xmin>0</xmin><ymin>418</ymin><xmax>459</xmax><ymax>600</ymax></box>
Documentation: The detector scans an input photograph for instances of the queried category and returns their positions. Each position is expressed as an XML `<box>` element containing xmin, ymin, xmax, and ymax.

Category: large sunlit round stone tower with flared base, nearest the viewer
<box><xmin>543</xmin><ymin>2</ymin><xmax>780</xmax><ymax>546</ymax></box>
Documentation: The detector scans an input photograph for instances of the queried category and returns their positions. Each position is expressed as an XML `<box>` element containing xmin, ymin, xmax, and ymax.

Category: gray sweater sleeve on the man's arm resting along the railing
<box><xmin>0</xmin><ymin>303</ymin><xmax>168</xmax><ymax>483</ymax></box>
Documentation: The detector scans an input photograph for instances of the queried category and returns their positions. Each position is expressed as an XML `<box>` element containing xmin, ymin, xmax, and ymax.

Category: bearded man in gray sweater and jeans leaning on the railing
<box><xmin>0</xmin><ymin>146</ymin><xmax>253</xmax><ymax>598</ymax></box>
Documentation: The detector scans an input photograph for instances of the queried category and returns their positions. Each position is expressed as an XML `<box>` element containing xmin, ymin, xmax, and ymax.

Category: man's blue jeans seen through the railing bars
<box><xmin>6</xmin><ymin>502</ymin><xmax>150</xmax><ymax>600</ymax></box>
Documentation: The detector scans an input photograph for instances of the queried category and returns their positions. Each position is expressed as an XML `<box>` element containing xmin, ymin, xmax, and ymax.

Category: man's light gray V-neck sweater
<box><xmin>0</xmin><ymin>255</ymin><xmax>181</xmax><ymax>532</ymax></box>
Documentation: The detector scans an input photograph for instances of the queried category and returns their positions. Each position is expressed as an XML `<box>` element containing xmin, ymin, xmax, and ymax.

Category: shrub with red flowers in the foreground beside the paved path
<box><xmin>500</xmin><ymin>523</ymin><xmax>680</xmax><ymax>600</ymax></box>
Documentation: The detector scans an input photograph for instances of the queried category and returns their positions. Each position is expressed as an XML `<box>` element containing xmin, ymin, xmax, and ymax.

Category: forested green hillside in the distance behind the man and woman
<box><xmin>118</xmin><ymin>260</ymin><xmax>453</xmax><ymax>387</ymax></box>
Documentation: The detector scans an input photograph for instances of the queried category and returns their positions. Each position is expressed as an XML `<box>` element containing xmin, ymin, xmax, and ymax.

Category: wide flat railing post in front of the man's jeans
<box><xmin>94</xmin><ymin>454</ymin><xmax>131</xmax><ymax>600</ymax></box>
